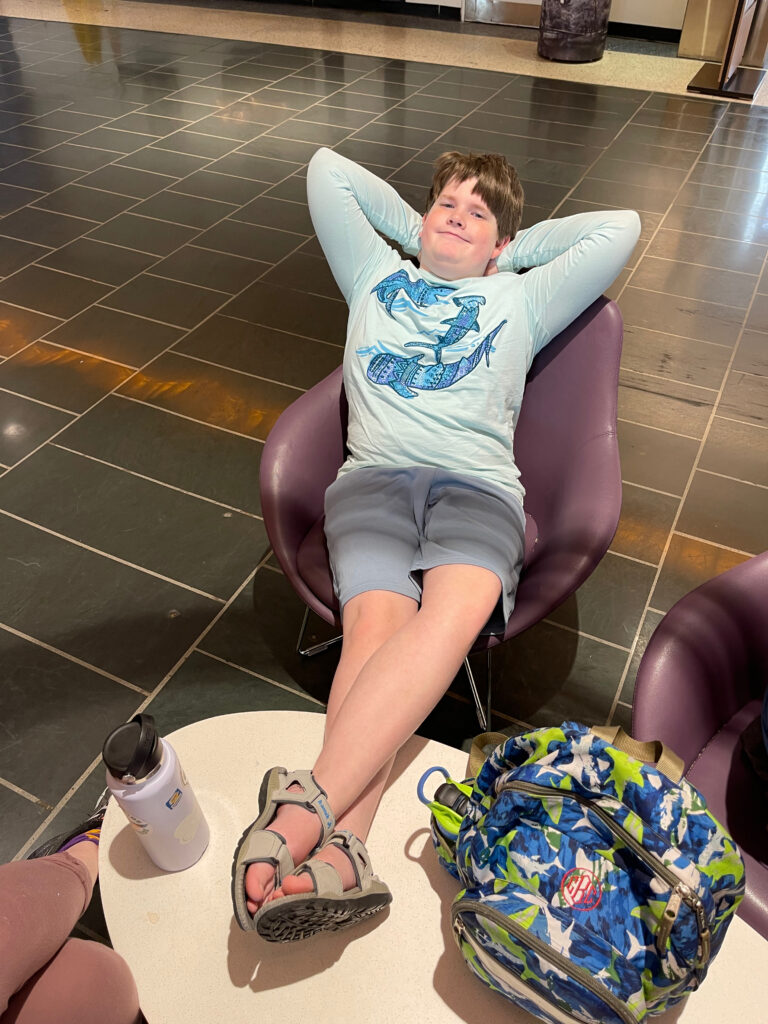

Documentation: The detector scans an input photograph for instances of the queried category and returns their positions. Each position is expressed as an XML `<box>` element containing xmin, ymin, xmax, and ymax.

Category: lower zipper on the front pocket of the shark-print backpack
<box><xmin>452</xmin><ymin>899</ymin><xmax>637</xmax><ymax>1024</ymax></box>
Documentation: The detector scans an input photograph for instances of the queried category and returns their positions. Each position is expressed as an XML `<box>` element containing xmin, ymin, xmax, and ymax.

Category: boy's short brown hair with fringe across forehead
<box><xmin>427</xmin><ymin>153</ymin><xmax>524</xmax><ymax>239</ymax></box>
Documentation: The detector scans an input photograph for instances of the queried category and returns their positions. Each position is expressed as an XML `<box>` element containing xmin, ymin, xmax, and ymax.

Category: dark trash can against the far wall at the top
<box><xmin>539</xmin><ymin>0</ymin><xmax>610</xmax><ymax>63</ymax></box>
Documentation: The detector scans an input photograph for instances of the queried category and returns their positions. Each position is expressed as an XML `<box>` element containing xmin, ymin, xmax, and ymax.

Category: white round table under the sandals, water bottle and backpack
<box><xmin>99</xmin><ymin>712</ymin><xmax>768</xmax><ymax>1024</ymax></box>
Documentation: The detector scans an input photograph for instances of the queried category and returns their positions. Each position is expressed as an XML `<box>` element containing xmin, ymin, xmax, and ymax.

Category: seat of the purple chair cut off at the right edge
<box><xmin>687</xmin><ymin>700</ymin><xmax>768</xmax><ymax>938</ymax></box>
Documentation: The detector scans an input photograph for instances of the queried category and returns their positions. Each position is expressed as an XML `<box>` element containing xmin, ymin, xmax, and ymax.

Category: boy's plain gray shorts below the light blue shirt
<box><xmin>326</xmin><ymin>466</ymin><xmax>525</xmax><ymax>633</ymax></box>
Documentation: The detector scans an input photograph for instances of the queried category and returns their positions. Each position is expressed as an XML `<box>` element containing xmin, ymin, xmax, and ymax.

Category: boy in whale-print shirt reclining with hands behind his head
<box><xmin>232</xmin><ymin>150</ymin><xmax>639</xmax><ymax>941</ymax></box>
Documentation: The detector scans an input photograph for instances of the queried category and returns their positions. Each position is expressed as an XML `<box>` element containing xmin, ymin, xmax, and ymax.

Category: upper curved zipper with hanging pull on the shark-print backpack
<box><xmin>497</xmin><ymin>779</ymin><xmax>712</xmax><ymax>970</ymax></box>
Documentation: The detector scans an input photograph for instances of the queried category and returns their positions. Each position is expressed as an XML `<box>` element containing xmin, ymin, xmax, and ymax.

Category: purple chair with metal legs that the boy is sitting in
<box><xmin>261</xmin><ymin>298</ymin><xmax>623</xmax><ymax>730</ymax></box>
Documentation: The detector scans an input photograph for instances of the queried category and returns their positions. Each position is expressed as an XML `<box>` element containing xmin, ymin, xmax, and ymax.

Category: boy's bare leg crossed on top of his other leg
<box><xmin>244</xmin><ymin>565</ymin><xmax>501</xmax><ymax>912</ymax></box>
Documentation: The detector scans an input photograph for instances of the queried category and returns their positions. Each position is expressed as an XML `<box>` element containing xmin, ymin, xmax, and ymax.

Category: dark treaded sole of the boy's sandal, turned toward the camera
<box><xmin>256</xmin><ymin>892</ymin><xmax>392</xmax><ymax>942</ymax></box>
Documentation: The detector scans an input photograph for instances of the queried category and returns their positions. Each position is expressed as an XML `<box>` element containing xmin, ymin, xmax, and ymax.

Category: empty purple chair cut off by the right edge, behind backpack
<box><xmin>632</xmin><ymin>552</ymin><xmax>768</xmax><ymax>938</ymax></box>
